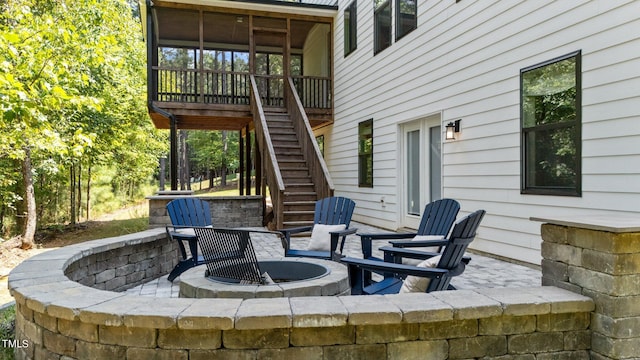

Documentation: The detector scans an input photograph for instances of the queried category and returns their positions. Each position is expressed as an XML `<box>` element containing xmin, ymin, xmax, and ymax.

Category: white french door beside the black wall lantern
<box><xmin>399</xmin><ymin>115</ymin><xmax>442</xmax><ymax>228</ymax></box>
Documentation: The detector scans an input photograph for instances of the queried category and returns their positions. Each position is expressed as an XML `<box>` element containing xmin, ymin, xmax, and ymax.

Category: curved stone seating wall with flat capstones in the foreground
<box><xmin>9</xmin><ymin>229</ymin><xmax>594</xmax><ymax>360</ymax></box>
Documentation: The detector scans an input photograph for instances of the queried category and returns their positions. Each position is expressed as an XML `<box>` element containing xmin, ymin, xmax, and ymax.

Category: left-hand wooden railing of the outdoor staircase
<box><xmin>250</xmin><ymin>75</ymin><xmax>285</xmax><ymax>229</ymax></box>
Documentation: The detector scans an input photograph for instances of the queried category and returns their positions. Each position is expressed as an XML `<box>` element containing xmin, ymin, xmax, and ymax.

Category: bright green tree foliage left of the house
<box><xmin>0</xmin><ymin>0</ymin><xmax>167</xmax><ymax>236</ymax></box>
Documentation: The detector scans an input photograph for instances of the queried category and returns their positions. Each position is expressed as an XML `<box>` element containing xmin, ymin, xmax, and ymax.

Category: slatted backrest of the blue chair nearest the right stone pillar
<box><xmin>427</xmin><ymin>210</ymin><xmax>485</xmax><ymax>292</ymax></box>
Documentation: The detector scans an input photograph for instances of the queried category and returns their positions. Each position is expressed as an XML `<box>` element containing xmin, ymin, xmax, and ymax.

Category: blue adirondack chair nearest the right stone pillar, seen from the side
<box><xmin>341</xmin><ymin>210</ymin><xmax>485</xmax><ymax>295</ymax></box>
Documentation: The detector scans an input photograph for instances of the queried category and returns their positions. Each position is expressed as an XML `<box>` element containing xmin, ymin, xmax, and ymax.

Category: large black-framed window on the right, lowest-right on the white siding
<box><xmin>520</xmin><ymin>51</ymin><xmax>582</xmax><ymax>196</ymax></box>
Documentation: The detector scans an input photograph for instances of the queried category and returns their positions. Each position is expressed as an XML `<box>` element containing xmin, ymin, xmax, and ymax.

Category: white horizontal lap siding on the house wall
<box><xmin>322</xmin><ymin>0</ymin><xmax>640</xmax><ymax>263</ymax></box>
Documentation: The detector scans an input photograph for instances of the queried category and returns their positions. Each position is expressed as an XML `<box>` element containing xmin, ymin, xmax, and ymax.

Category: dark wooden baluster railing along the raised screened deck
<box><xmin>153</xmin><ymin>66</ymin><xmax>332</xmax><ymax>109</ymax></box>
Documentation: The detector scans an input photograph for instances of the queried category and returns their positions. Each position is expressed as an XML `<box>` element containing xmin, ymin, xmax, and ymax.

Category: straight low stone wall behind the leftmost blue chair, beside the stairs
<box><xmin>147</xmin><ymin>193</ymin><xmax>264</xmax><ymax>228</ymax></box>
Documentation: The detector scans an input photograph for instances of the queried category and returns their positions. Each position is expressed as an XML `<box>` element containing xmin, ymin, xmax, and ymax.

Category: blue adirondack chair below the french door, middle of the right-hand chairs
<box><xmin>358</xmin><ymin>199</ymin><xmax>460</xmax><ymax>260</ymax></box>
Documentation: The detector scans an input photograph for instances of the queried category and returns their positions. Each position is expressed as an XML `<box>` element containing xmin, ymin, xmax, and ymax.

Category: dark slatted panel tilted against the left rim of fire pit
<box><xmin>195</xmin><ymin>227</ymin><xmax>262</xmax><ymax>283</ymax></box>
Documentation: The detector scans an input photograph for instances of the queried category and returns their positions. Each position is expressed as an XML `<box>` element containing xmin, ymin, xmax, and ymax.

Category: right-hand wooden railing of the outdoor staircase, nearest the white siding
<box><xmin>285</xmin><ymin>76</ymin><xmax>334</xmax><ymax>198</ymax></box>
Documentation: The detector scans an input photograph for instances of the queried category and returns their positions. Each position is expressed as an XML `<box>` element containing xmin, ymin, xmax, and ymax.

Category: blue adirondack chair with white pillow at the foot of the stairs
<box><xmin>278</xmin><ymin>196</ymin><xmax>357</xmax><ymax>259</ymax></box>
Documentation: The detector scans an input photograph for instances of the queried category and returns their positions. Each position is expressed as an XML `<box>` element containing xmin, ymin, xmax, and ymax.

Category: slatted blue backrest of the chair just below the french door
<box><xmin>417</xmin><ymin>199</ymin><xmax>460</xmax><ymax>237</ymax></box>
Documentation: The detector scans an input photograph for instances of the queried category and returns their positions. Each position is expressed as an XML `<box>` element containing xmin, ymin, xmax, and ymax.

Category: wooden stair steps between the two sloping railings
<box><xmin>264</xmin><ymin>109</ymin><xmax>318</xmax><ymax>228</ymax></box>
